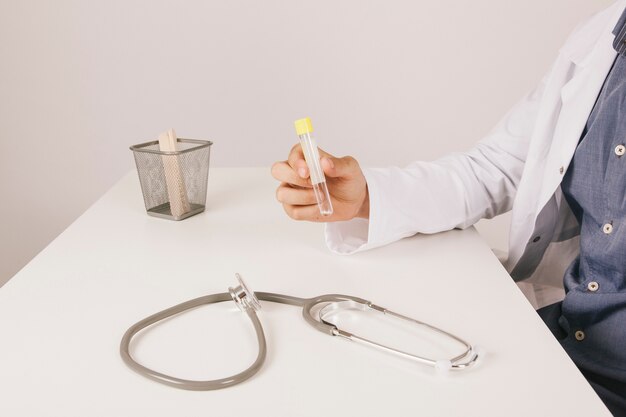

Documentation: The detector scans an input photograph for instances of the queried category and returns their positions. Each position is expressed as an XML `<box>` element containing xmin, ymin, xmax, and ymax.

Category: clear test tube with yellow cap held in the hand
<box><xmin>295</xmin><ymin>117</ymin><xmax>333</xmax><ymax>216</ymax></box>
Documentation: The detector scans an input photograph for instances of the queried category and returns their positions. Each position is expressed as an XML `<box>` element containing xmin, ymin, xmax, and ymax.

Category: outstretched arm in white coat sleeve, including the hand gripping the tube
<box><xmin>272</xmin><ymin>72</ymin><xmax>545</xmax><ymax>254</ymax></box>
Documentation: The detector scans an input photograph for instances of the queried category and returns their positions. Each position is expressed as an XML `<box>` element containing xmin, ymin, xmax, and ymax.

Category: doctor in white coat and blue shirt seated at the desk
<box><xmin>272</xmin><ymin>0</ymin><xmax>626</xmax><ymax>416</ymax></box>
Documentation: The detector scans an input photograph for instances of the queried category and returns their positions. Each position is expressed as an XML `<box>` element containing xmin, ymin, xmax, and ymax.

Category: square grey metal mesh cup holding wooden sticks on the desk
<box><xmin>130</xmin><ymin>139</ymin><xmax>213</xmax><ymax>220</ymax></box>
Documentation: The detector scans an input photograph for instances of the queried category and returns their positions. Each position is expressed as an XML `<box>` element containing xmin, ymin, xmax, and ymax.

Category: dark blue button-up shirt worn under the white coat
<box><xmin>558</xmin><ymin>5</ymin><xmax>626</xmax><ymax>415</ymax></box>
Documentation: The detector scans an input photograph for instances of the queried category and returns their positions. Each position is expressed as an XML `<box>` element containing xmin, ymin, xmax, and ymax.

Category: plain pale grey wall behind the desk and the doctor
<box><xmin>0</xmin><ymin>0</ymin><xmax>611</xmax><ymax>285</ymax></box>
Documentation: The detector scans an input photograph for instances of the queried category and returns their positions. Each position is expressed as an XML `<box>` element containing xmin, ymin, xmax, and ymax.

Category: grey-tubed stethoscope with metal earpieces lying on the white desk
<box><xmin>120</xmin><ymin>274</ymin><xmax>479</xmax><ymax>391</ymax></box>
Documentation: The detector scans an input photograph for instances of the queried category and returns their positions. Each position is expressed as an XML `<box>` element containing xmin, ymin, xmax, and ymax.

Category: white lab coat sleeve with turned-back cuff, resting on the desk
<box><xmin>325</xmin><ymin>75</ymin><xmax>549</xmax><ymax>254</ymax></box>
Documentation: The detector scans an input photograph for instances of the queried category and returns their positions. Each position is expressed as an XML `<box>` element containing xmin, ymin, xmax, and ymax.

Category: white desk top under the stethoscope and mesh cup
<box><xmin>0</xmin><ymin>169</ymin><xmax>609</xmax><ymax>417</ymax></box>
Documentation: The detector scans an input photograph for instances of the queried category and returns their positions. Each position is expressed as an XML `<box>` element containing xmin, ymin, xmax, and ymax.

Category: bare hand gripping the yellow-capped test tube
<box><xmin>272</xmin><ymin>144</ymin><xmax>369</xmax><ymax>222</ymax></box>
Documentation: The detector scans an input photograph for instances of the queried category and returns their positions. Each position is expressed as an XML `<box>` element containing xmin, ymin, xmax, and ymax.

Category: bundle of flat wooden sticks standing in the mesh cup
<box><xmin>159</xmin><ymin>129</ymin><xmax>191</xmax><ymax>217</ymax></box>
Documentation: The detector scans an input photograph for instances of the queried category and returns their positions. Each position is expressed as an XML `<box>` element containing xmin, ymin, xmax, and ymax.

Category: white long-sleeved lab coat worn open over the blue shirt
<box><xmin>326</xmin><ymin>0</ymin><xmax>626</xmax><ymax>308</ymax></box>
